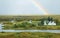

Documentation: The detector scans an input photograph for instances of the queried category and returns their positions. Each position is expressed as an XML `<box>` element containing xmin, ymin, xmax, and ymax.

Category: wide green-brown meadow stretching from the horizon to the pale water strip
<box><xmin>0</xmin><ymin>15</ymin><xmax>60</xmax><ymax>30</ymax></box>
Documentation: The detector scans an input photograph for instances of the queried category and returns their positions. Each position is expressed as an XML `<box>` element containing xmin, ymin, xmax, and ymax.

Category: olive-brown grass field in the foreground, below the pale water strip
<box><xmin>0</xmin><ymin>32</ymin><xmax>60</xmax><ymax>38</ymax></box>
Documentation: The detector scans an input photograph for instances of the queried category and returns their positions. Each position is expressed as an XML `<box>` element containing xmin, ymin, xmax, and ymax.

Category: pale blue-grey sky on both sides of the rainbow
<box><xmin>0</xmin><ymin>0</ymin><xmax>60</xmax><ymax>15</ymax></box>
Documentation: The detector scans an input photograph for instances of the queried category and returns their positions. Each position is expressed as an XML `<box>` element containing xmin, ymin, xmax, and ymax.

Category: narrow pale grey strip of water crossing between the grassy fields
<box><xmin>0</xmin><ymin>30</ymin><xmax>60</xmax><ymax>33</ymax></box>
